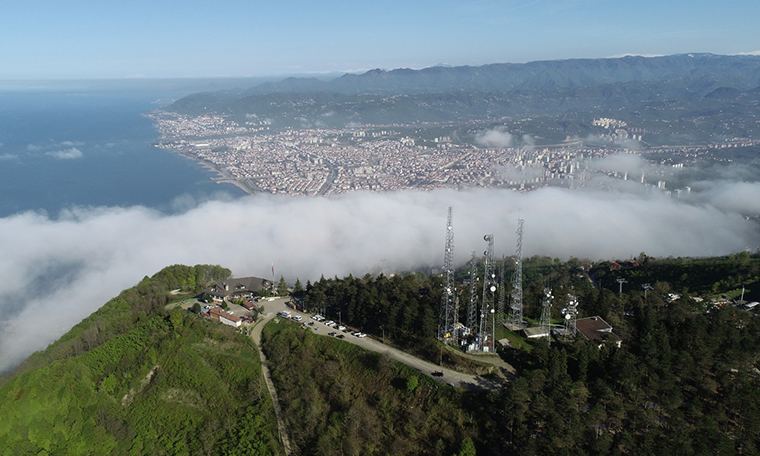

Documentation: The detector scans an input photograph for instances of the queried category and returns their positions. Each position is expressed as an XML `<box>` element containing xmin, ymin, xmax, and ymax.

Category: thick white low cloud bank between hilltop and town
<box><xmin>0</xmin><ymin>183</ymin><xmax>760</xmax><ymax>372</ymax></box>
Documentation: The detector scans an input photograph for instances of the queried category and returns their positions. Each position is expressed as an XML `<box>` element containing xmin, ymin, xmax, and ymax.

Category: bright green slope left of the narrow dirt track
<box><xmin>0</xmin><ymin>266</ymin><xmax>282</xmax><ymax>455</ymax></box>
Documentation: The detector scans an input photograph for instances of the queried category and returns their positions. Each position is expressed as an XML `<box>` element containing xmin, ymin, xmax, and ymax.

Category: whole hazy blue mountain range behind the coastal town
<box><xmin>165</xmin><ymin>54</ymin><xmax>760</xmax><ymax>140</ymax></box>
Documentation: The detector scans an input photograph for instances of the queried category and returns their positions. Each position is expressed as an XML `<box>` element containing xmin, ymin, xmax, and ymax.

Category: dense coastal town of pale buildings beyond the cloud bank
<box><xmin>149</xmin><ymin>111</ymin><xmax>746</xmax><ymax>196</ymax></box>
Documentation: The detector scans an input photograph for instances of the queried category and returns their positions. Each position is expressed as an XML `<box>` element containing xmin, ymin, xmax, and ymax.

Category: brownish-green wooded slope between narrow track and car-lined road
<box><xmin>264</xmin><ymin>321</ymin><xmax>489</xmax><ymax>455</ymax></box>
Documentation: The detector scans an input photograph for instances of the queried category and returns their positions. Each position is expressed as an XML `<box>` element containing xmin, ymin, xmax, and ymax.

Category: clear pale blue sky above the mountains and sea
<box><xmin>0</xmin><ymin>0</ymin><xmax>760</xmax><ymax>79</ymax></box>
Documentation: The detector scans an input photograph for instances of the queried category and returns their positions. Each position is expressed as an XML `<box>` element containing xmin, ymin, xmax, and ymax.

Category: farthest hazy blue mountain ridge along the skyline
<box><xmin>246</xmin><ymin>54</ymin><xmax>760</xmax><ymax>95</ymax></box>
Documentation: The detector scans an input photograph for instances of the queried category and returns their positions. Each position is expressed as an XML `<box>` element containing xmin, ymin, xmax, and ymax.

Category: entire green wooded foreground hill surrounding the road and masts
<box><xmin>0</xmin><ymin>252</ymin><xmax>760</xmax><ymax>456</ymax></box>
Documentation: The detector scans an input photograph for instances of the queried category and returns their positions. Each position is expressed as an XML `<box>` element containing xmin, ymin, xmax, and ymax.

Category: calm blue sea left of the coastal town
<box><xmin>0</xmin><ymin>81</ymin><xmax>264</xmax><ymax>219</ymax></box>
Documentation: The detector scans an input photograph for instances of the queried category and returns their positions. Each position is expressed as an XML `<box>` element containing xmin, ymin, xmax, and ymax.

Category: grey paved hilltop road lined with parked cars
<box><xmin>254</xmin><ymin>298</ymin><xmax>511</xmax><ymax>391</ymax></box>
